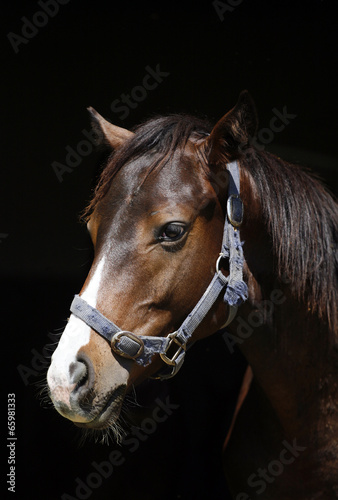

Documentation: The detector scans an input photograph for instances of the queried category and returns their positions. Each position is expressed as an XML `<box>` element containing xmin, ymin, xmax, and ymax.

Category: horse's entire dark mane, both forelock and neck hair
<box><xmin>82</xmin><ymin>114</ymin><xmax>338</xmax><ymax>331</ymax></box>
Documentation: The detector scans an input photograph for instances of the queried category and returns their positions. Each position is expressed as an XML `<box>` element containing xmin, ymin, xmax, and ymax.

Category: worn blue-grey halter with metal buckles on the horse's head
<box><xmin>70</xmin><ymin>162</ymin><xmax>248</xmax><ymax>379</ymax></box>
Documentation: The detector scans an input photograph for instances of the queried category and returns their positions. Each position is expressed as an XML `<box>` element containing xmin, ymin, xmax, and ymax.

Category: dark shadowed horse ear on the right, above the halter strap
<box><xmin>205</xmin><ymin>90</ymin><xmax>258</xmax><ymax>165</ymax></box>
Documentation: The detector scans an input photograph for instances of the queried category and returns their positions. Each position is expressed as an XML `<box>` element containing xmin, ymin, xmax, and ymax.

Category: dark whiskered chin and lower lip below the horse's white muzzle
<box><xmin>74</xmin><ymin>385</ymin><xmax>127</xmax><ymax>431</ymax></box>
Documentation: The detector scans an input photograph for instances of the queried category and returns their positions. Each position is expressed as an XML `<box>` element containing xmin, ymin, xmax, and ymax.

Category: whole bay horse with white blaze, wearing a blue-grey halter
<box><xmin>47</xmin><ymin>91</ymin><xmax>338</xmax><ymax>500</ymax></box>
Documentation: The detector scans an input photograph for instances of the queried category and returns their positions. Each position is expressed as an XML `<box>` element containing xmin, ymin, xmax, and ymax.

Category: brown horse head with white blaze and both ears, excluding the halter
<box><xmin>48</xmin><ymin>92</ymin><xmax>256</xmax><ymax>436</ymax></box>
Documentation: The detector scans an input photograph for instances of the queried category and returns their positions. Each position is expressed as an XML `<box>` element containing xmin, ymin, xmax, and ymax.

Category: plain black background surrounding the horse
<box><xmin>0</xmin><ymin>0</ymin><xmax>338</xmax><ymax>500</ymax></box>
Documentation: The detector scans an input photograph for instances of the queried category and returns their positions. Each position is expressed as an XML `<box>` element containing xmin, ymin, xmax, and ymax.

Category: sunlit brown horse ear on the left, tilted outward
<box><xmin>87</xmin><ymin>107</ymin><xmax>134</xmax><ymax>149</ymax></box>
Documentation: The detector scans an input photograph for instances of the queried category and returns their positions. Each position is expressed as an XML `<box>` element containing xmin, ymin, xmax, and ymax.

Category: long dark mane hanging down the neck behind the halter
<box><xmin>243</xmin><ymin>148</ymin><xmax>338</xmax><ymax>333</ymax></box>
